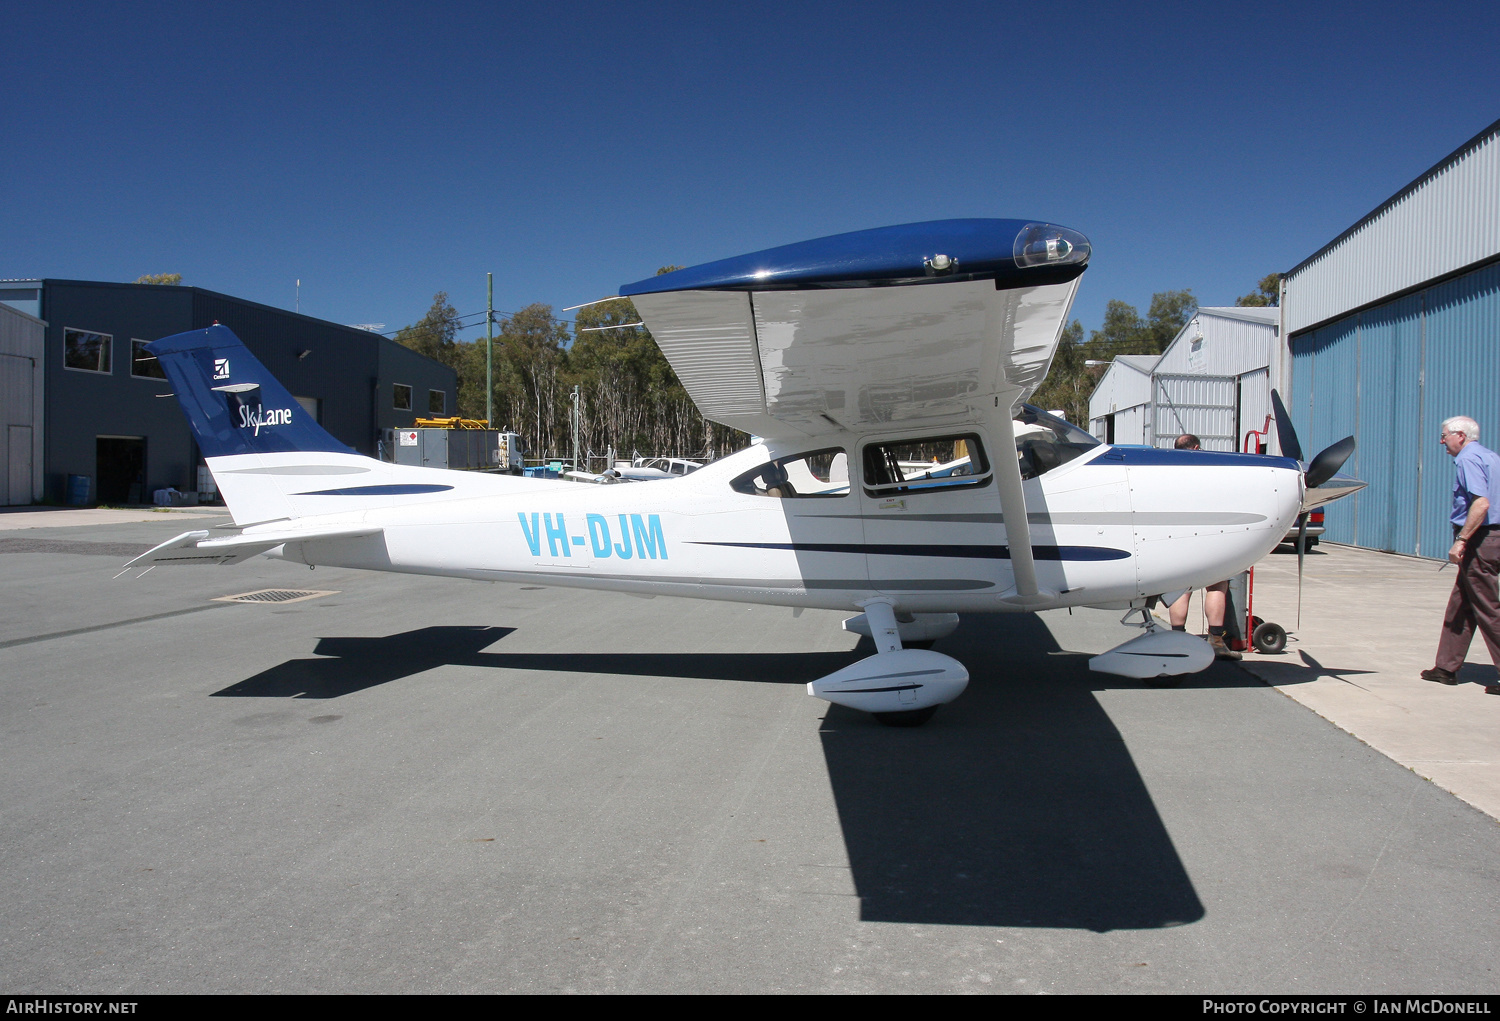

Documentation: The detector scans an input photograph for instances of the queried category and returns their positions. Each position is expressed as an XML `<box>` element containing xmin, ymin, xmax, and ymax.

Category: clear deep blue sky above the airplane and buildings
<box><xmin>0</xmin><ymin>1</ymin><xmax>1500</xmax><ymax>341</ymax></box>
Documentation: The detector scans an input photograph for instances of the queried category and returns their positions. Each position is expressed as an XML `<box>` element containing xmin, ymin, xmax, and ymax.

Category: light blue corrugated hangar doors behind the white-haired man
<box><xmin>1290</xmin><ymin>256</ymin><xmax>1500</xmax><ymax>559</ymax></box>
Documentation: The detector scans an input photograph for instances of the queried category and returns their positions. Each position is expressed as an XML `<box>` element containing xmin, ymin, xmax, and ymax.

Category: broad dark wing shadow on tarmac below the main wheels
<box><xmin>821</xmin><ymin>613</ymin><xmax>1206</xmax><ymax>933</ymax></box>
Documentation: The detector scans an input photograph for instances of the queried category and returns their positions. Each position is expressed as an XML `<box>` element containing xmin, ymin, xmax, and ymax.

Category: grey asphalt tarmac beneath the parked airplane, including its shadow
<box><xmin>0</xmin><ymin>514</ymin><xmax>1500</xmax><ymax>994</ymax></box>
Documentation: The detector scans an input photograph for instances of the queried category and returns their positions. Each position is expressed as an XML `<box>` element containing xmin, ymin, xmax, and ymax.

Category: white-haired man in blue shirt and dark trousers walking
<box><xmin>1422</xmin><ymin>415</ymin><xmax>1500</xmax><ymax>694</ymax></box>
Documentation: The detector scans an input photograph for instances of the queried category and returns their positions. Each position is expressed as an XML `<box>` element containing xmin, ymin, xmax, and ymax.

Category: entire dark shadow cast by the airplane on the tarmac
<box><xmin>215</xmin><ymin>613</ymin><xmax>1206</xmax><ymax>931</ymax></box>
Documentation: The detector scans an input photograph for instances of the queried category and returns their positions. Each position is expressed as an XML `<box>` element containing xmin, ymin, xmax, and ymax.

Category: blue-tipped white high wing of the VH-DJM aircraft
<box><xmin>620</xmin><ymin>220</ymin><xmax>1089</xmax><ymax>438</ymax></box>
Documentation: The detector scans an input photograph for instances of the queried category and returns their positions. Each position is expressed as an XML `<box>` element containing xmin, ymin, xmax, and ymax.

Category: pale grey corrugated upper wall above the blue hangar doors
<box><xmin>1286</xmin><ymin>121</ymin><xmax>1500</xmax><ymax>334</ymax></box>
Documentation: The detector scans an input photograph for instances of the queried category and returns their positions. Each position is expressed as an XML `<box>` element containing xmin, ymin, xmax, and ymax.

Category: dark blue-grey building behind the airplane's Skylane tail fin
<box><xmin>0</xmin><ymin>279</ymin><xmax>458</xmax><ymax>504</ymax></box>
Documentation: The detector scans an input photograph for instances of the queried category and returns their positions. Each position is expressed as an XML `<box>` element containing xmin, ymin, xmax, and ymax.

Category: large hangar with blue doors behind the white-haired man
<box><xmin>1281</xmin><ymin>121</ymin><xmax>1500</xmax><ymax>559</ymax></box>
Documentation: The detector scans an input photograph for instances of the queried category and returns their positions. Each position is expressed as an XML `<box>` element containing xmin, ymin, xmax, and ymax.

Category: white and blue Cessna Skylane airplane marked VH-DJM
<box><xmin>131</xmin><ymin>219</ymin><xmax>1361</xmax><ymax>724</ymax></box>
